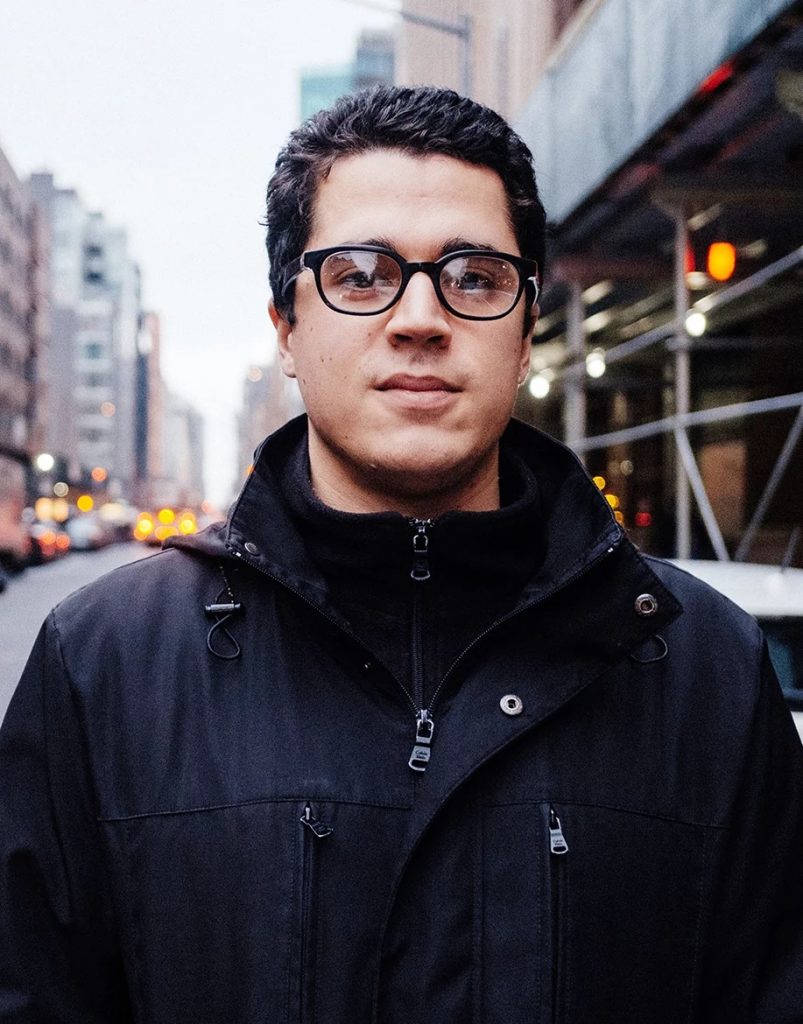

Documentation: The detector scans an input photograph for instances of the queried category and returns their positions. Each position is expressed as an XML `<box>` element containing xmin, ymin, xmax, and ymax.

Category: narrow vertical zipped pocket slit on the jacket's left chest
<box><xmin>289</xmin><ymin>802</ymin><xmax>334</xmax><ymax>1024</ymax></box>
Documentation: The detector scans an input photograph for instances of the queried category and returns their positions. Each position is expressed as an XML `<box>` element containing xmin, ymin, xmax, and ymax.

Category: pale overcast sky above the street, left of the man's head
<box><xmin>0</xmin><ymin>0</ymin><xmax>393</xmax><ymax>501</ymax></box>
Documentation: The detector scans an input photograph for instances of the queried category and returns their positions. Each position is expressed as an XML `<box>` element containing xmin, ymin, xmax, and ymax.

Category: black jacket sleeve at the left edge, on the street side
<box><xmin>0</xmin><ymin>613</ymin><xmax>131</xmax><ymax>1024</ymax></box>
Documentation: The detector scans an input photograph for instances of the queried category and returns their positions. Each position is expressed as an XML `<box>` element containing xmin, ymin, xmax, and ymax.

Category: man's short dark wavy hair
<box><xmin>265</xmin><ymin>86</ymin><xmax>546</xmax><ymax>324</ymax></box>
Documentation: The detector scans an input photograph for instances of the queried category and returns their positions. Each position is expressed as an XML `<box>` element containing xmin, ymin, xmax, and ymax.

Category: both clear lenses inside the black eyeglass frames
<box><xmin>321</xmin><ymin>250</ymin><xmax>519</xmax><ymax>317</ymax></box>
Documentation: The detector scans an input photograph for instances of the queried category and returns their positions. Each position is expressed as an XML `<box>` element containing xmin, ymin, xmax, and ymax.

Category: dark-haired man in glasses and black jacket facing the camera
<box><xmin>0</xmin><ymin>88</ymin><xmax>803</xmax><ymax>1024</ymax></box>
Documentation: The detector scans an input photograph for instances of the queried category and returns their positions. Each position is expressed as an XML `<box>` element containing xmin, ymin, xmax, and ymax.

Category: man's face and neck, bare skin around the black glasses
<box><xmin>271</xmin><ymin>150</ymin><xmax>531</xmax><ymax>514</ymax></box>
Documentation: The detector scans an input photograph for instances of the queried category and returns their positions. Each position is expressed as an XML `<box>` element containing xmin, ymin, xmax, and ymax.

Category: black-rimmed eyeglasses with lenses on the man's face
<box><xmin>282</xmin><ymin>245</ymin><xmax>538</xmax><ymax>319</ymax></box>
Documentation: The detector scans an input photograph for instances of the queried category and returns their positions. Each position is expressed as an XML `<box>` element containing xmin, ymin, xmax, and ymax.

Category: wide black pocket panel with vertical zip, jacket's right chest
<box><xmin>480</xmin><ymin>801</ymin><xmax>708</xmax><ymax>1024</ymax></box>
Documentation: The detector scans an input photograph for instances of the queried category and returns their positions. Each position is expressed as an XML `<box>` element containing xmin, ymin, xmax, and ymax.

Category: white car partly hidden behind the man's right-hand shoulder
<box><xmin>673</xmin><ymin>559</ymin><xmax>803</xmax><ymax>739</ymax></box>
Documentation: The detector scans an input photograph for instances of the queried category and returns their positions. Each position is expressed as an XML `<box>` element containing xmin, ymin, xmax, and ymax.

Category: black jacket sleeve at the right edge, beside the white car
<box><xmin>700</xmin><ymin>645</ymin><xmax>803</xmax><ymax>1024</ymax></box>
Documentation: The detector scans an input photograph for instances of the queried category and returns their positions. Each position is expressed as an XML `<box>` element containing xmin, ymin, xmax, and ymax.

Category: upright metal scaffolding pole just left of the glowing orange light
<box><xmin>675</xmin><ymin>207</ymin><xmax>696</xmax><ymax>558</ymax></box>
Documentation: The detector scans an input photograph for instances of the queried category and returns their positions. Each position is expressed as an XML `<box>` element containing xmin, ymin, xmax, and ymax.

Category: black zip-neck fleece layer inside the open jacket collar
<box><xmin>281</xmin><ymin>438</ymin><xmax>543</xmax><ymax>707</ymax></box>
